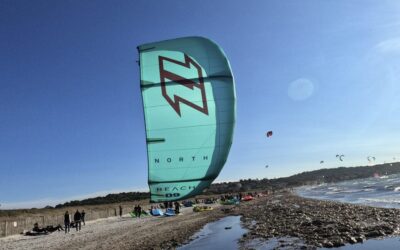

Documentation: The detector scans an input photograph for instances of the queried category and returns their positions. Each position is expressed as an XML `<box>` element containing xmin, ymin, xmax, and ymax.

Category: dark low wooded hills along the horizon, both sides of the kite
<box><xmin>0</xmin><ymin>163</ymin><xmax>400</xmax><ymax>212</ymax></box>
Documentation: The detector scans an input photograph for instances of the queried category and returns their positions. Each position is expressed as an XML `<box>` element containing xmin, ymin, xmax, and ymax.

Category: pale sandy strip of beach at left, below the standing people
<box><xmin>0</xmin><ymin>204</ymin><xmax>224</xmax><ymax>250</ymax></box>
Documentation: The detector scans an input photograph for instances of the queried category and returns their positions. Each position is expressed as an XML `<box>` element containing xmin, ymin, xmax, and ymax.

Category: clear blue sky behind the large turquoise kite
<box><xmin>0</xmin><ymin>0</ymin><xmax>400</xmax><ymax>208</ymax></box>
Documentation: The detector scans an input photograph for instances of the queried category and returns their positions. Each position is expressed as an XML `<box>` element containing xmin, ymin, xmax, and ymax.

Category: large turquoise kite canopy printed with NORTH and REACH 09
<box><xmin>138</xmin><ymin>37</ymin><xmax>236</xmax><ymax>202</ymax></box>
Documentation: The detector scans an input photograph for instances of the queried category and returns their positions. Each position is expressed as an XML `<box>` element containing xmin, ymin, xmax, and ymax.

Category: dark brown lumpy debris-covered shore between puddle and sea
<box><xmin>236</xmin><ymin>192</ymin><xmax>400</xmax><ymax>248</ymax></box>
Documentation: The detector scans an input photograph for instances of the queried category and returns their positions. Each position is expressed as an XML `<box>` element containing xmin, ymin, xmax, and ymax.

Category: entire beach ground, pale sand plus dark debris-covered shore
<box><xmin>0</xmin><ymin>192</ymin><xmax>400</xmax><ymax>249</ymax></box>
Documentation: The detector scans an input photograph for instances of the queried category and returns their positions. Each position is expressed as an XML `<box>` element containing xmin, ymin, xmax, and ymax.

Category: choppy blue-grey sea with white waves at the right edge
<box><xmin>296</xmin><ymin>174</ymin><xmax>400</xmax><ymax>208</ymax></box>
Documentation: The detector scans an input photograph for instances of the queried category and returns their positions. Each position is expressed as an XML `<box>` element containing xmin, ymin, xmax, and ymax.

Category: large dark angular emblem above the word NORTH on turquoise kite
<box><xmin>158</xmin><ymin>54</ymin><xmax>208</xmax><ymax>116</ymax></box>
